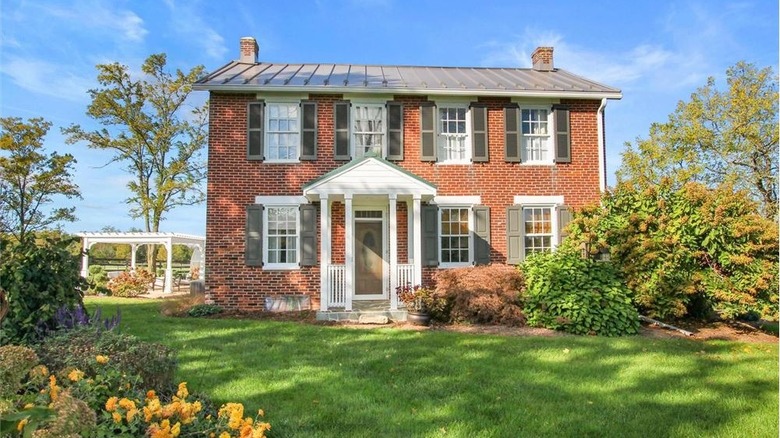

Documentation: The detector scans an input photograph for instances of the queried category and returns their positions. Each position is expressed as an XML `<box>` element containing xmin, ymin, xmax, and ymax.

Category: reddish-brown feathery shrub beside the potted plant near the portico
<box><xmin>436</xmin><ymin>265</ymin><xmax>525</xmax><ymax>326</ymax></box>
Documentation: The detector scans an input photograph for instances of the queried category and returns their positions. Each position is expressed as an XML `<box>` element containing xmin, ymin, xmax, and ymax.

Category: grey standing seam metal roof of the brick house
<box><xmin>194</xmin><ymin>61</ymin><xmax>622</xmax><ymax>99</ymax></box>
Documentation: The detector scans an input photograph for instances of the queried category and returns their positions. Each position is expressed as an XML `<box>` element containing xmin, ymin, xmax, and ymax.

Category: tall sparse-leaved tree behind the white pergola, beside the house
<box><xmin>63</xmin><ymin>54</ymin><xmax>208</xmax><ymax>265</ymax></box>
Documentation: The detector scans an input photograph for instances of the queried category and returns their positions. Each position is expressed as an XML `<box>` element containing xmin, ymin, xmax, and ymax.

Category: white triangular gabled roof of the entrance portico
<box><xmin>303</xmin><ymin>156</ymin><xmax>436</xmax><ymax>199</ymax></box>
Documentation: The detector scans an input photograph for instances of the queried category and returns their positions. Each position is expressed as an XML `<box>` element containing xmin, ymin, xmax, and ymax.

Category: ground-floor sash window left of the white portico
<box><xmin>263</xmin><ymin>206</ymin><xmax>299</xmax><ymax>269</ymax></box>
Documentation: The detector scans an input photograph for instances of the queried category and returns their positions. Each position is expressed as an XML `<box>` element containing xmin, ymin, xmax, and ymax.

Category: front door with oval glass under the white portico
<box><xmin>355</xmin><ymin>219</ymin><xmax>385</xmax><ymax>299</ymax></box>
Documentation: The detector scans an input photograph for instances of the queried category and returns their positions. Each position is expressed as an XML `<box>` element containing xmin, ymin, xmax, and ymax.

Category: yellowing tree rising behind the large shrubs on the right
<box><xmin>617</xmin><ymin>62</ymin><xmax>778</xmax><ymax>218</ymax></box>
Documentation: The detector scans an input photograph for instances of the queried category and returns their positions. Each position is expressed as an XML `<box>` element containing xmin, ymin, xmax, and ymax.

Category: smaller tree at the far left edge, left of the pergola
<box><xmin>0</xmin><ymin>117</ymin><xmax>81</xmax><ymax>241</ymax></box>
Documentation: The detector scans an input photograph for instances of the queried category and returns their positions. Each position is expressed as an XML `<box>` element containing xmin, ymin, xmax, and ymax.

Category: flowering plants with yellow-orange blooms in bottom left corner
<box><xmin>0</xmin><ymin>347</ymin><xmax>271</xmax><ymax>438</ymax></box>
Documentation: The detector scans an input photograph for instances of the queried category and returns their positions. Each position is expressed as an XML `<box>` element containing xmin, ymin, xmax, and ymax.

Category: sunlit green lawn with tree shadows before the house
<box><xmin>82</xmin><ymin>298</ymin><xmax>778</xmax><ymax>438</ymax></box>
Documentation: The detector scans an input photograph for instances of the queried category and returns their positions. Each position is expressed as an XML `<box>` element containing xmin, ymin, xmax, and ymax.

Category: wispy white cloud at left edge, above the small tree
<box><xmin>0</xmin><ymin>56</ymin><xmax>94</xmax><ymax>102</ymax></box>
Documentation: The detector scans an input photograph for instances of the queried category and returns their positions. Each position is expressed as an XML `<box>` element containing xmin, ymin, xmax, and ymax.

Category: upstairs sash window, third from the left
<box><xmin>437</xmin><ymin>105</ymin><xmax>471</xmax><ymax>163</ymax></box>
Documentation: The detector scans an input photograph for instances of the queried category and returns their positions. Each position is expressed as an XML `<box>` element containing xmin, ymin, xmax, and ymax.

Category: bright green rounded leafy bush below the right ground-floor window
<box><xmin>521</xmin><ymin>247</ymin><xmax>639</xmax><ymax>336</ymax></box>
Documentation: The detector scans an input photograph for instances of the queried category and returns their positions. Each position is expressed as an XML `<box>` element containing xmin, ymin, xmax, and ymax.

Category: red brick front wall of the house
<box><xmin>206</xmin><ymin>93</ymin><xmax>600</xmax><ymax>309</ymax></box>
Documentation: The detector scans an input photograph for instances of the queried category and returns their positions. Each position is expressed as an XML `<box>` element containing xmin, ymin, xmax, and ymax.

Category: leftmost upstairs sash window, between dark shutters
<box><xmin>265</xmin><ymin>103</ymin><xmax>300</xmax><ymax>162</ymax></box>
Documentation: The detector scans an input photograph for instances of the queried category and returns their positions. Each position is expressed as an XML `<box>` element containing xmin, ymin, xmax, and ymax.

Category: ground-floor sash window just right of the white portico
<box><xmin>439</xmin><ymin>207</ymin><xmax>472</xmax><ymax>267</ymax></box>
